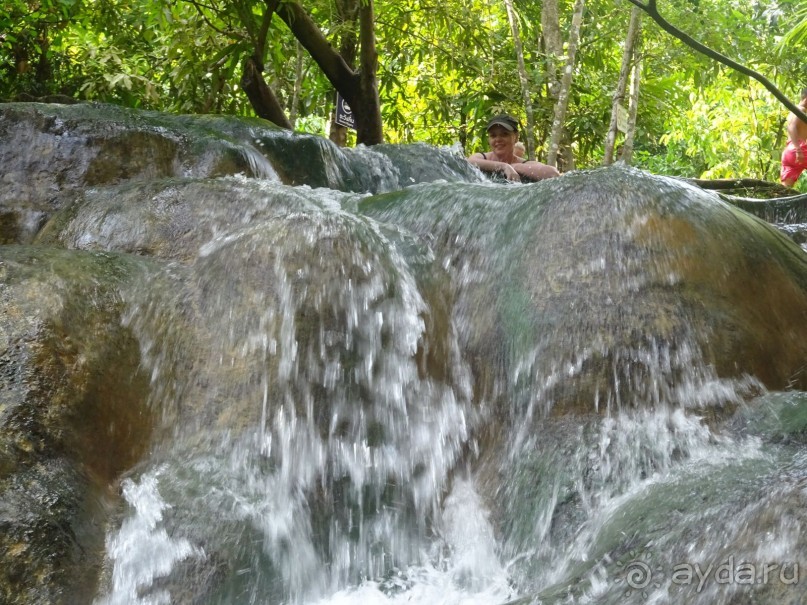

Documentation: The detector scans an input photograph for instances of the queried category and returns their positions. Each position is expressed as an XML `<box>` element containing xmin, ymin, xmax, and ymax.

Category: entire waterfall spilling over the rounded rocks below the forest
<box><xmin>0</xmin><ymin>101</ymin><xmax>807</xmax><ymax>605</ymax></box>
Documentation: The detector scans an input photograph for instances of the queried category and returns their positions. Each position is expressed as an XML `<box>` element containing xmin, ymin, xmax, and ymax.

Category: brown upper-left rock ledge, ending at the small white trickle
<box><xmin>0</xmin><ymin>103</ymin><xmax>272</xmax><ymax>243</ymax></box>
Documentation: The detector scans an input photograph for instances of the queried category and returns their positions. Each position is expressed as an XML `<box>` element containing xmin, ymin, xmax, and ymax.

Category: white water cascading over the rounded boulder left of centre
<box><xmin>94</xmin><ymin>185</ymin><xmax>486</xmax><ymax>603</ymax></box>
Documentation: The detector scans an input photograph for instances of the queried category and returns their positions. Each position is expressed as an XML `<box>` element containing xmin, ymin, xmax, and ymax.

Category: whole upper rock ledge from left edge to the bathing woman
<box><xmin>0</xmin><ymin>103</ymin><xmax>482</xmax><ymax>243</ymax></box>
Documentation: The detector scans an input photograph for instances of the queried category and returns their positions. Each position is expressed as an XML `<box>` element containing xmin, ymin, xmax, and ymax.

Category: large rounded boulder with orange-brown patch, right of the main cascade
<box><xmin>360</xmin><ymin>167</ymin><xmax>807</xmax><ymax>418</ymax></box>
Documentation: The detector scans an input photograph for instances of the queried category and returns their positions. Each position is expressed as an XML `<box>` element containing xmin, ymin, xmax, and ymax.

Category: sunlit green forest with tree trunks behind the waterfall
<box><xmin>0</xmin><ymin>0</ymin><xmax>807</xmax><ymax>190</ymax></box>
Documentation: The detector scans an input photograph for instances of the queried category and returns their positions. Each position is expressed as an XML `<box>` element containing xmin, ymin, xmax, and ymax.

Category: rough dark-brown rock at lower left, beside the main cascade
<box><xmin>0</xmin><ymin>246</ymin><xmax>153</xmax><ymax>605</ymax></box>
